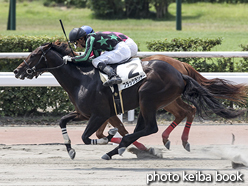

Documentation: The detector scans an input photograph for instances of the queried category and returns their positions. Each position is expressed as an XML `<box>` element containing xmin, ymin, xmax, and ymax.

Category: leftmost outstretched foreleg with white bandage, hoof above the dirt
<box><xmin>59</xmin><ymin>112</ymin><xmax>79</xmax><ymax>159</ymax></box>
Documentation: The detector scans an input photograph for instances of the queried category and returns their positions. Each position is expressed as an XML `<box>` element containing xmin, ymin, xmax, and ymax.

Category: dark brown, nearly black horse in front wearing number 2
<box><xmin>14</xmin><ymin>43</ymin><xmax>243</xmax><ymax>160</ymax></box>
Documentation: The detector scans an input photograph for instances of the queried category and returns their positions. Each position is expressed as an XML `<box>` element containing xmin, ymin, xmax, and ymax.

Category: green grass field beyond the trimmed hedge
<box><xmin>0</xmin><ymin>0</ymin><xmax>248</xmax><ymax>51</ymax></box>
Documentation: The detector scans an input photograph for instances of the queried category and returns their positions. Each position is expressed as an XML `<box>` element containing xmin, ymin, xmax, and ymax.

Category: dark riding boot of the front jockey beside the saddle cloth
<box><xmin>97</xmin><ymin>62</ymin><xmax>122</xmax><ymax>86</ymax></box>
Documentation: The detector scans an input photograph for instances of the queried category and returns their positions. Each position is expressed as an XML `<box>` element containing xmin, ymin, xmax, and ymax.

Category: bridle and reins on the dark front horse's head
<box><xmin>24</xmin><ymin>46</ymin><xmax>65</xmax><ymax>75</ymax></box>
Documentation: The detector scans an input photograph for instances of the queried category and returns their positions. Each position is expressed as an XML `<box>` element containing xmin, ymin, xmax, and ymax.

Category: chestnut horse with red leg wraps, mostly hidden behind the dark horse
<box><xmin>60</xmin><ymin>55</ymin><xmax>248</xmax><ymax>151</ymax></box>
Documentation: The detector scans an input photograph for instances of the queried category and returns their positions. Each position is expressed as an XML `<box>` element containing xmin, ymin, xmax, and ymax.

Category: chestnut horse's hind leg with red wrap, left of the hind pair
<box><xmin>162</xmin><ymin>98</ymin><xmax>187</xmax><ymax>149</ymax></box>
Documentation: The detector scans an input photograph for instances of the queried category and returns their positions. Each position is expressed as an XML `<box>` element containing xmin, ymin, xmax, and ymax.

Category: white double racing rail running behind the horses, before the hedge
<box><xmin>0</xmin><ymin>52</ymin><xmax>248</xmax><ymax>121</ymax></box>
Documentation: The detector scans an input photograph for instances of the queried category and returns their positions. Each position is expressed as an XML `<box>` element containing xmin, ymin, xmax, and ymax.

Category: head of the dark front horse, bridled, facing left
<box><xmin>14</xmin><ymin>43</ymin><xmax>52</xmax><ymax>79</ymax></box>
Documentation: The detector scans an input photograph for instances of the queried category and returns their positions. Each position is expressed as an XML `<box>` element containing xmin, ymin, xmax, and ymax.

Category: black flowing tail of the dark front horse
<box><xmin>182</xmin><ymin>74</ymin><xmax>244</xmax><ymax>119</ymax></box>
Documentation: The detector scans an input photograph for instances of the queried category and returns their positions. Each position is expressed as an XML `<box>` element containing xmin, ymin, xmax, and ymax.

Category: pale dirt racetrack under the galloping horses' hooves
<box><xmin>0</xmin><ymin>124</ymin><xmax>248</xmax><ymax>186</ymax></box>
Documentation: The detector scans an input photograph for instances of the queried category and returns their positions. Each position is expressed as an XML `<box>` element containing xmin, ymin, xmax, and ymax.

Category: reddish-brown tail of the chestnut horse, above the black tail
<box><xmin>183</xmin><ymin>62</ymin><xmax>248</xmax><ymax>104</ymax></box>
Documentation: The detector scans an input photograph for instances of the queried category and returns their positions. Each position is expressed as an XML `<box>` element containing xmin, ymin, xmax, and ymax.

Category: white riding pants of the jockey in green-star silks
<box><xmin>92</xmin><ymin>41</ymin><xmax>131</xmax><ymax>68</ymax></box>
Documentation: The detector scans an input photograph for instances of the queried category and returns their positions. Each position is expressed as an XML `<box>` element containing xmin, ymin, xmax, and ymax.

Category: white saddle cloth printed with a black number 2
<box><xmin>99</xmin><ymin>58</ymin><xmax>146</xmax><ymax>91</ymax></box>
